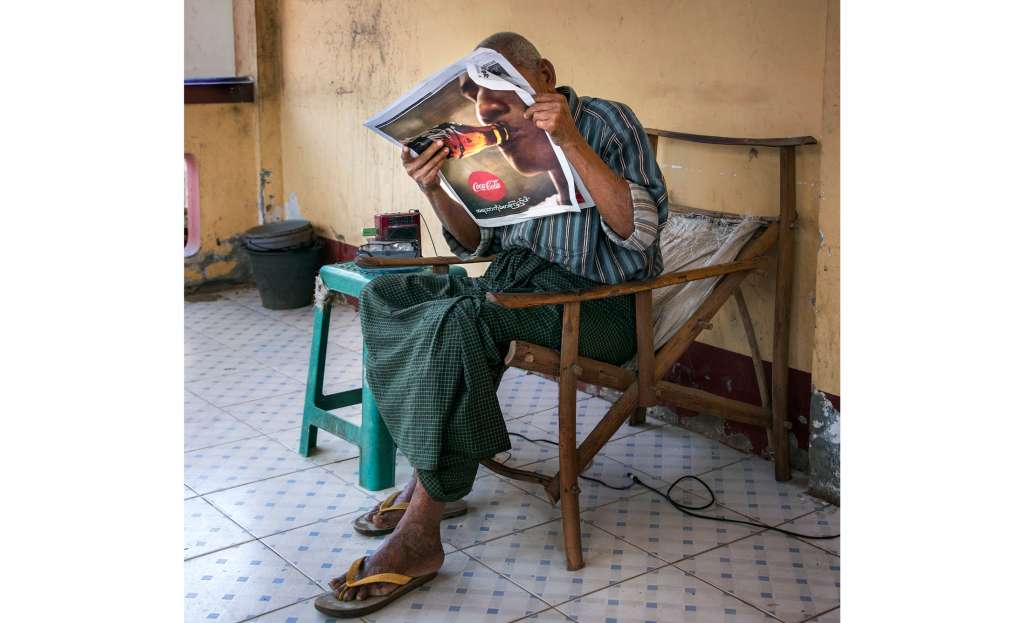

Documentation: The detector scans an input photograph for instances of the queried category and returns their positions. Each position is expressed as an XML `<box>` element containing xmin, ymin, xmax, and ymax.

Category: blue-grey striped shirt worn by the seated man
<box><xmin>443</xmin><ymin>86</ymin><xmax>669</xmax><ymax>284</ymax></box>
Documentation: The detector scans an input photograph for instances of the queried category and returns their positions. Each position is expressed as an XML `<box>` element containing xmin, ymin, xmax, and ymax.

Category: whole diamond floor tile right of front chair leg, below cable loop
<box><xmin>583</xmin><ymin>493</ymin><xmax>758</xmax><ymax>563</ymax></box>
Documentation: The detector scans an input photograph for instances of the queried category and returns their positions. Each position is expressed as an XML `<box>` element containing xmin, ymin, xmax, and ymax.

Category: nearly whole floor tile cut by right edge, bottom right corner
<box><xmin>677</xmin><ymin>532</ymin><xmax>840</xmax><ymax>623</ymax></box>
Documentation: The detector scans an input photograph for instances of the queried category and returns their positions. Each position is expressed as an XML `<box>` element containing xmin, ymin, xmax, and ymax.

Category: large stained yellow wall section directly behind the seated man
<box><xmin>278</xmin><ymin>0</ymin><xmax>839</xmax><ymax>377</ymax></box>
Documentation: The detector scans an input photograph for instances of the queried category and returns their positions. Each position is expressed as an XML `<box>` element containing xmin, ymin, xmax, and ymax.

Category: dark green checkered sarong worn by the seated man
<box><xmin>359</xmin><ymin>249</ymin><xmax>636</xmax><ymax>502</ymax></box>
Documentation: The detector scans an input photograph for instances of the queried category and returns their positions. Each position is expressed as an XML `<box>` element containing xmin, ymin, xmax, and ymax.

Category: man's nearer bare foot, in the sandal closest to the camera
<box><xmin>330</xmin><ymin>479</ymin><xmax>444</xmax><ymax>601</ymax></box>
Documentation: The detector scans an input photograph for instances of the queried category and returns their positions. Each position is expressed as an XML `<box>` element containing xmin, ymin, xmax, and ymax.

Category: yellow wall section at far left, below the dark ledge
<box><xmin>184</xmin><ymin>103</ymin><xmax>259</xmax><ymax>286</ymax></box>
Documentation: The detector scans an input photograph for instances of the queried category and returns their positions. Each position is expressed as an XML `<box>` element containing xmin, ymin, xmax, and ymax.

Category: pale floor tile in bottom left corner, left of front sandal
<box><xmin>184</xmin><ymin>541</ymin><xmax>321</xmax><ymax>622</ymax></box>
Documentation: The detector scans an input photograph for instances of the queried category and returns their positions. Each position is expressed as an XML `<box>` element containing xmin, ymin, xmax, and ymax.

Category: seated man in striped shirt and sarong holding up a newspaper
<box><xmin>316</xmin><ymin>33</ymin><xmax>668</xmax><ymax>617</ymax></box>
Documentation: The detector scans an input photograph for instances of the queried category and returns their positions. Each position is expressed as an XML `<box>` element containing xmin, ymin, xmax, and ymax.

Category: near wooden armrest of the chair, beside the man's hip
<box><xmin>487</xmin><ymin>255</ymin><xmax>769</xmax><ymax>309</ymax></box>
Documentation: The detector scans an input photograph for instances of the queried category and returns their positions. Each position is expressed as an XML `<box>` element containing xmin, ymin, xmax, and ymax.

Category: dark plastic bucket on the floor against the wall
<box><xmin>243</xmin><ymin>219</ymin><xmax>319</xmax><ymax>309</ymax></box>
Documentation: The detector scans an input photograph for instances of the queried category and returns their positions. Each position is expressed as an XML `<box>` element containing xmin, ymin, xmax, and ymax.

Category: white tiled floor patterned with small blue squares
<box><xmin>183</xmin><ymin>289</ymin><xmax>840</xmax><ymax>623</ymax></box>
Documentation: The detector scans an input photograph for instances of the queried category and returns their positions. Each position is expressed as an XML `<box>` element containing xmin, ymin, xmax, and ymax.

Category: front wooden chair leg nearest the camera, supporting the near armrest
<box><xmin>558</xmin><ymin>302</ymin><xmax>584</xmax><ymax>571</ymax></box>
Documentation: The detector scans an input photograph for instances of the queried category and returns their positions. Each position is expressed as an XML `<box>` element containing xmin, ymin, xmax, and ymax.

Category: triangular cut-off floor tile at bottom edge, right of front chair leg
<box><xmin>558</xmin><ymin>567</ymin><xmax>774</xmax><ymax>623</ymax></box>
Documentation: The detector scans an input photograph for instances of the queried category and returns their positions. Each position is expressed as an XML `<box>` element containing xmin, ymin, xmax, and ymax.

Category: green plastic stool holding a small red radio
<box><xmin>299</xmin><ymin>261</ymin><xmax>466</xmax><ymax>491</ymax></box>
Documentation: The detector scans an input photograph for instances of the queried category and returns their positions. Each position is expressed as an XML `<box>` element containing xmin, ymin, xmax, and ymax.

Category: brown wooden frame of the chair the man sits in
<box><xmin>359</xmin><ymin>129</ymin><xmax>817</xmax><ymax>571</ymax></box>
